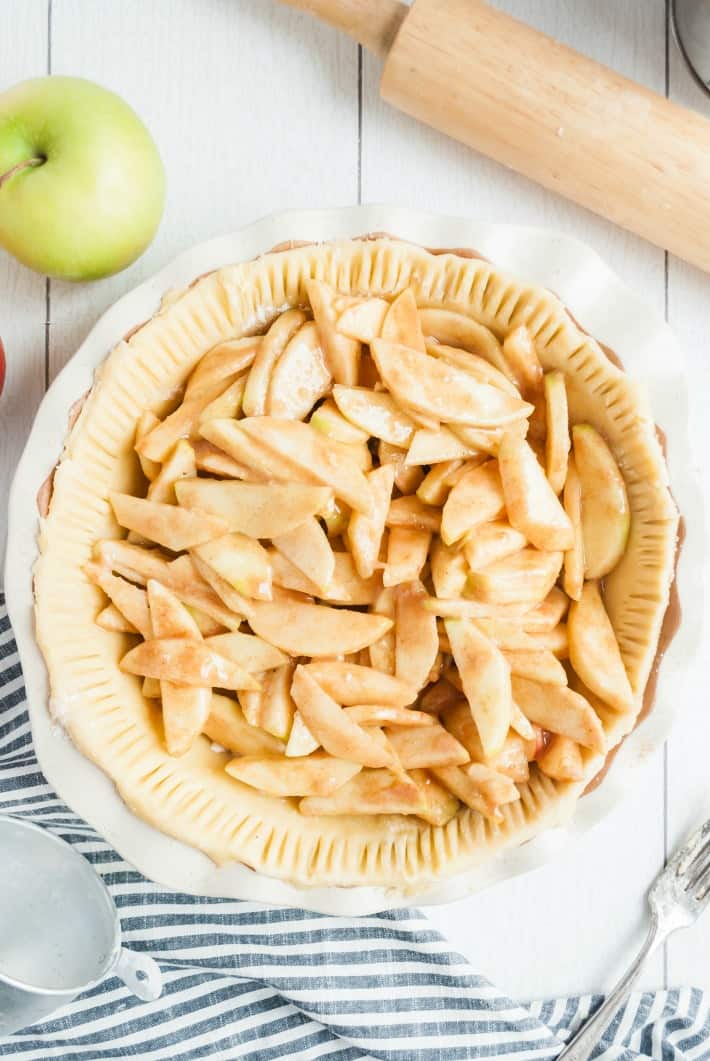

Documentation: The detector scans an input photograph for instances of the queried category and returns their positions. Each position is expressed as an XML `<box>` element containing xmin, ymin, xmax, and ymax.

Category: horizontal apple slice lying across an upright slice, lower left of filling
<box><xmin>120</xmin><ymin>638</ymin><xmax>259</xmax><ymax>690</ymax></box>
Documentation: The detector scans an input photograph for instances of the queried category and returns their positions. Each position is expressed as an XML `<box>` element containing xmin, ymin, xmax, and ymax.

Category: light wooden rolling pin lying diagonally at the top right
<box><xmin>287</xmin><ymin>0</ymin><xmax>710</xmax><ymax>272</ymax></box>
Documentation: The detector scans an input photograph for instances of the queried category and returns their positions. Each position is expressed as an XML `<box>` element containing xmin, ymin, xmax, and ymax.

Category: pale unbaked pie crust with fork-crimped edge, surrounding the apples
<box><xmin>35</xmin><ymin>238</ymin><xmax>678</xmax><ymax>889</ymax></box>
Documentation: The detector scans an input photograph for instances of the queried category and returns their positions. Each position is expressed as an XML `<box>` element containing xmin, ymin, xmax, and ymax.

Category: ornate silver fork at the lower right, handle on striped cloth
<box><xmin>557</xmin><ymin>818</ymin><xmax>710</xmax><ymax>1061</ymax></box>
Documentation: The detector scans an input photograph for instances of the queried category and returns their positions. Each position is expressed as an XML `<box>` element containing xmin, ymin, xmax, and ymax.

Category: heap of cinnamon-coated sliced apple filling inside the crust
<box><xmin>86</xmin><ymin>280</ymin><xmax>636</xmax><ymax>825</ymax></box>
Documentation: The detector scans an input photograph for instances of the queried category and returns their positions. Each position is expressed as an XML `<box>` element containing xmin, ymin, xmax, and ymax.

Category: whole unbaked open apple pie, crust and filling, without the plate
<box><xmin>35</xmin><ymin>238</ymin><xmax>678</xmax><ymax>889</ymax></box>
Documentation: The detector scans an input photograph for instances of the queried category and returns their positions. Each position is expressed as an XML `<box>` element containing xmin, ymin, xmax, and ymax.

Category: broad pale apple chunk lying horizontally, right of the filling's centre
<box><xmin>468</xmin><ymin>549</ymin><xmax>562</xmax><ymax>605</ymax></box>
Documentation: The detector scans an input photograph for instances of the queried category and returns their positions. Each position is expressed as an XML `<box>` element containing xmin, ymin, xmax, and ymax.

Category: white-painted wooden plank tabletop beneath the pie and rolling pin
<box><xmin>0</xmin><ymin>0</ymin><xmax>710</xmax><ymax>998</ymax></box>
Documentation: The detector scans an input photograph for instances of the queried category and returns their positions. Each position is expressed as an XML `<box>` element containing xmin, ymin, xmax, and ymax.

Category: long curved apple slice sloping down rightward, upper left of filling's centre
<box><xmin>241</xmin><ymin>416</ymin><xmax>373</xmax><ymax>516</ymax></box>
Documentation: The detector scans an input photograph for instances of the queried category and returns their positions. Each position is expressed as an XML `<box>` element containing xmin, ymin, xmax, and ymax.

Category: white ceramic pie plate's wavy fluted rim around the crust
<box><xmin>5</xmin><ymin>206</ymin><xmax>706</xmax><ymax>916</ymax></box>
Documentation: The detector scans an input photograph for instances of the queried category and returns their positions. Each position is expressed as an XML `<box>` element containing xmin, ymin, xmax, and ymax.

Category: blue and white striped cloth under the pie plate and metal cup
<box><xmin>0</xmin><ymin>596</ymin><xmax>710</xmax><ymax>1061</ymax></box>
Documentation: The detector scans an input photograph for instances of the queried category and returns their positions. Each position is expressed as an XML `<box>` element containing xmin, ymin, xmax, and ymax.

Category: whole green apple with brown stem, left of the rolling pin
<box><xmin>0</xmin><ymin>76</ymin><xmax>164</xmax><ymax>280</ymax></box>
